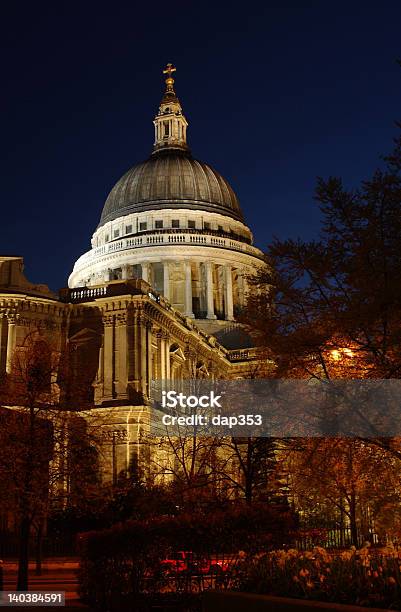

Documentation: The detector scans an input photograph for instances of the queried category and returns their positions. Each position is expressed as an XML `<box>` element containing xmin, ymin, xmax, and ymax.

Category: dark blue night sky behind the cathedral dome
<box><xmin>0</xmin><ymin>0</ymin><xmax>401</xmax><ymax>288</ymax></box>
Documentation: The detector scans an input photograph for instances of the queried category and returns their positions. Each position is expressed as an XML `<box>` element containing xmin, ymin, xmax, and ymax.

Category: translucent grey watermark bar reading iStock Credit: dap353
<box><xmin>150</xmin><ymin>379</ymin><xmax>401</xmax><ymax>438</ymax></box>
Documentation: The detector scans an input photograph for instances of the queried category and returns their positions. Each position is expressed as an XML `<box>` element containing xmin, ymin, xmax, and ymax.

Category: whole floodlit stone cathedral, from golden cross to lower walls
<box><xmin>0</xmin><ymin>65</ymin><xmax>266</xmax><ymax>486</ymax></box>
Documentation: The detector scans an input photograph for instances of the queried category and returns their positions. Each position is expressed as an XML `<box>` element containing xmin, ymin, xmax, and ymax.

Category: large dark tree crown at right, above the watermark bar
<box><xmin>244</xmin><ymin>126</ymin><xmax>401</xmax><ymax>379</ymax></box>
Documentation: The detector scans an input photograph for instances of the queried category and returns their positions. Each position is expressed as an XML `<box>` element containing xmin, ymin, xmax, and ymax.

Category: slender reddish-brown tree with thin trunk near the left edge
<box><xmin>0</xmin><ymin>334</ymin><xmax>56</xmax><ymax>590</ymax></box>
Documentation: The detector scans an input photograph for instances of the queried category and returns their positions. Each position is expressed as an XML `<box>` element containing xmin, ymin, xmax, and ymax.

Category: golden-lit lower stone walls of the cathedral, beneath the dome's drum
<box><xmin>0</xmin><ymin>257</ymin><xmax>258</xmax><ymax>481</ymax></box>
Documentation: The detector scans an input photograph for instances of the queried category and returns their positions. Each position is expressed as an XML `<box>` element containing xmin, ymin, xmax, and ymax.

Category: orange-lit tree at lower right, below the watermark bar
<box><xmin>286</xmin><ymin>438</ymin><xmax>401</xmax><ymax>546</ymax></box>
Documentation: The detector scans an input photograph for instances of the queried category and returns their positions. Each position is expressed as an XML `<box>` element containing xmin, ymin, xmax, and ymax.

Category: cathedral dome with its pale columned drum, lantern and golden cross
<box><xmin>68</xmin><ymin>64</ymin><xmax>264</xmax><ymax>326</ymax></box>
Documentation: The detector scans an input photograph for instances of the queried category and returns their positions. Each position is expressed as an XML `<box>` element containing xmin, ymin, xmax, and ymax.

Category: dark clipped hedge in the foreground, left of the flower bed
<box><xmin>79</xmin><ymin>504</ymin><xmax>294</xmax><ymax>610</ymax></box>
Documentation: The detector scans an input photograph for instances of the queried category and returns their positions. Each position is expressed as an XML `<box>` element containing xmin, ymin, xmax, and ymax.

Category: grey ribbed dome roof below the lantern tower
<box><xmin>98</xmin><ymin>149</ymin><xmax>243</xmax><ymax>227</ymax></box>
